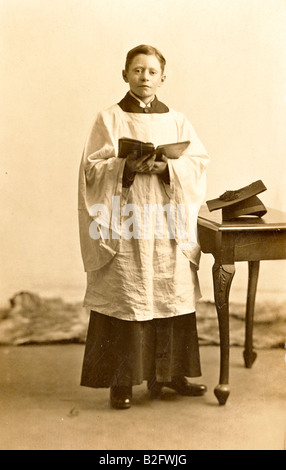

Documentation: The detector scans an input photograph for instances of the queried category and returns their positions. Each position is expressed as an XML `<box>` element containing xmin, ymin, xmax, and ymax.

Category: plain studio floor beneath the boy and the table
<box><xmin>0</xmin><ymin>344</ymin><xmax>286</xmax><ymax>450</ymax></box>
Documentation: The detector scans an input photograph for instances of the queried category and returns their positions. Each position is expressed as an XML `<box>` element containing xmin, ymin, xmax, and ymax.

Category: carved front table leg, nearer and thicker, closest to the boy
<box><xmin>213</xmin><ymin>263</ymin><xmax>235</xmax><ymax>405</ymax></box>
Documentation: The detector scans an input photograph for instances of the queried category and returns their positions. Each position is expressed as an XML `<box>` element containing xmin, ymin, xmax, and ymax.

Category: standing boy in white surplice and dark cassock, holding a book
<box><xmin>79</xmin><ymin>45</ymin><xmax>208</xmax><ymax>409</ymax></box>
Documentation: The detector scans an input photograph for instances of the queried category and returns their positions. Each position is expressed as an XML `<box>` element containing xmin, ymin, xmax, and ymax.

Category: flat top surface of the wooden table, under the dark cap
<box><xmin>198</xmin><ymin>206</ymin><xmax>286</xmax><ymax>232</ymax></box>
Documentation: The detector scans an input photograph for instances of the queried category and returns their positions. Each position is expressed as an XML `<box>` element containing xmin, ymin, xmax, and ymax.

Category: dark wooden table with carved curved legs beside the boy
<box><xmin>198</xmin><ymin>207</ymin><xmax>286</xmax><ymax>405</ymax></box>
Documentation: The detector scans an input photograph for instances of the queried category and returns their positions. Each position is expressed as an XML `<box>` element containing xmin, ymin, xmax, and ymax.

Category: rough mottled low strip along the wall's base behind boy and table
<box><xmin>0</xmin><ymin>292</ymin><xmax>286</xmax><ymax>348</ymax></box>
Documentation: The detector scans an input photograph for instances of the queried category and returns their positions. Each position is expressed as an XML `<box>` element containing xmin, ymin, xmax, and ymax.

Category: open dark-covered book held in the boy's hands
<box><xmin>118</xmin><ymin>137</ymin><xmax>191</xmax><ymax>160</ymax></box>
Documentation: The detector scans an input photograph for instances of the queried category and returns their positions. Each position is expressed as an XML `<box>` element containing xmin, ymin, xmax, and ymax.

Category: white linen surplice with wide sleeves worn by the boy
<box><xmin>79</xmin><ymin>97</ymin><xmax>209</xmax><ymax>321</ymax></box>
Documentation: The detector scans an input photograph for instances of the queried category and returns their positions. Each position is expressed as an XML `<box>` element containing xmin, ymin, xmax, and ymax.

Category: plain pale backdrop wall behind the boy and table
<box><xmin>0</xmin><ymin>0</ymin><xmax>286</xmax><ymax>304</ymax></box>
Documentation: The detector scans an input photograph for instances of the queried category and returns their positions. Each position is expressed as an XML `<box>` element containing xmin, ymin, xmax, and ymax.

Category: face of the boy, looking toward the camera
<box><xmin>123</xmin><ymin>54</ymin><xmax>166</xmax><ymax>104</ymax></box>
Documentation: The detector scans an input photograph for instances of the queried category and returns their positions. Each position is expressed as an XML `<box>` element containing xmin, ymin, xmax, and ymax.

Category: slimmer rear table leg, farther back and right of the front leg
<box><xmin>243</xmin><ymin>261</ymin><xmax>260</xmax><ymax>369</ymax></box>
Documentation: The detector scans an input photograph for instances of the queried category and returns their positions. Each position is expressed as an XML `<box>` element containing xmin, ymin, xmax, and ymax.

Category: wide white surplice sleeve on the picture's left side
<box><xmin>78</xmin><ymin>112</ymin><xmax>128</xmax><ymax>271</ymax></box>
